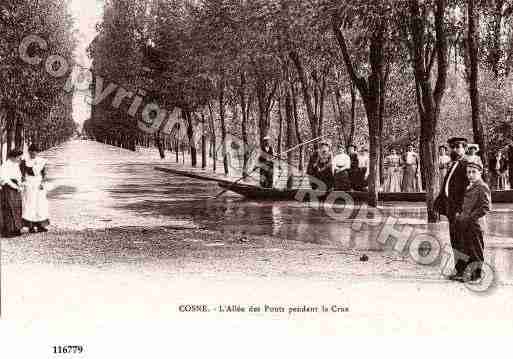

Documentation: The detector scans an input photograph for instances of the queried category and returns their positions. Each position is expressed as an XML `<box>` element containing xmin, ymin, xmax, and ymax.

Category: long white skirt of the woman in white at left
<box><xmin>22</xmin><ymin>176</ymin><xmax>50</xmax><ymax>227</ymax></box>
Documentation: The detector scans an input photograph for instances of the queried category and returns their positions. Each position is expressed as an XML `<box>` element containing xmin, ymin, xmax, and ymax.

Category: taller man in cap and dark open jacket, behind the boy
<box><xmin>435</xmin><ymin>137</ymin><xmax>469</xmax><ymax>280</ymax></box>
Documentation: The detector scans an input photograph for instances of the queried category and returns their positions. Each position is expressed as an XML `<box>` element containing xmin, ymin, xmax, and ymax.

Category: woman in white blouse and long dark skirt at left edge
<box><xmin>1</xmin><ymin>150</ymin><xmax>23</xmax><ymax>237</ymax></box>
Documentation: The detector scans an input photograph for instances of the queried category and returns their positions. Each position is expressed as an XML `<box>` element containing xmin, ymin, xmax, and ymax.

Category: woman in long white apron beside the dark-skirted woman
<box><xmin>20</xmin><ymin>145</ymin><xmax>50</xmax><ymax>233</ymax></box>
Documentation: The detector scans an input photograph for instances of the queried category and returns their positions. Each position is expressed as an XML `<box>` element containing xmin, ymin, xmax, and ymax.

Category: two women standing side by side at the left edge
<box><xmin>0</xmin><ymin>145</ymin><xmax>50</xmax><ymax>237</ymax></box>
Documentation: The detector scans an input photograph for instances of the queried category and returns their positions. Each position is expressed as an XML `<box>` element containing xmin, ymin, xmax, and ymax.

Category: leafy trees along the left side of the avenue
<box><xmin>0</xmin><ymin>0</ymin><xmax>77</xmax><ymax>158</ymax></box>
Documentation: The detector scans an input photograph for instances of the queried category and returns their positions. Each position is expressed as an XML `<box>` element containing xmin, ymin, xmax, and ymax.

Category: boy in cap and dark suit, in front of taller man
<box><xmin>456</xmin><ymin>161</ymin><xmax>491</xmax><ymax>281</ymax></box>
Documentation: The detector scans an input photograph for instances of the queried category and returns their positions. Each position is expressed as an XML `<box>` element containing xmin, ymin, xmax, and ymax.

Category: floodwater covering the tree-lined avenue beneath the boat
<box><xmin>45</xmin><ymin>141</ymin><xmax>513</xmax><ymax>273</ymax></box>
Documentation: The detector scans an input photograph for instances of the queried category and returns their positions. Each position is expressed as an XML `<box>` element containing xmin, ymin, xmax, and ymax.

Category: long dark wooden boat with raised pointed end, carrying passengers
<box><xmin>155</xmin><ymin>167</ymin><xmax>513</xmax><ymax>203</ymax></box>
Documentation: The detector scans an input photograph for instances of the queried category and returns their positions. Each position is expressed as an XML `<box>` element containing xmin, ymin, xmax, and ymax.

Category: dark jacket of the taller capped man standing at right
<box><xmin>435</xmin><ymin>158</ymin><xmax>469</xmax><ymax>219</ymax></box>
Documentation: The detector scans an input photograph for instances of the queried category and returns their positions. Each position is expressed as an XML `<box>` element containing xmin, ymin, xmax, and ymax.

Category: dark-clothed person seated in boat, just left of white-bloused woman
<box><xmin>307</xmin><ymin>140</ymin><xmax>335</xmax><ymax>190</ymax></box>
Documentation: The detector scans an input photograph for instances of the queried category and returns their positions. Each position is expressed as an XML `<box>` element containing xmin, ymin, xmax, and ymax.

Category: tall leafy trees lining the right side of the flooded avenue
<box><xmin>87</xmin><ymin>0</ymin><xmax>513</xmax><ymax>221</ymax></box>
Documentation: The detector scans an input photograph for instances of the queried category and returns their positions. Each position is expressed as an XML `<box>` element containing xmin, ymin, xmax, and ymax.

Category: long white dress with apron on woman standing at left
<box><xmin>22</xmin><ymin>157</ymin><xmax>49</xmax><ymax>225</ymax></box>
